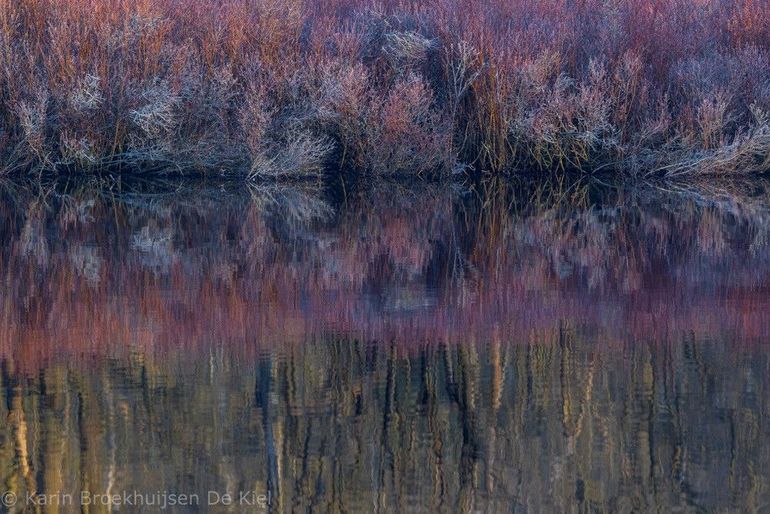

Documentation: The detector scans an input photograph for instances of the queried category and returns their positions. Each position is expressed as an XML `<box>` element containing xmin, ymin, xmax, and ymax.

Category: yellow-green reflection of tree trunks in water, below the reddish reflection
<box><xmin>0</xmin><ymin>334</ymin><xmax>770</xmax><ymax>512</ymax></box>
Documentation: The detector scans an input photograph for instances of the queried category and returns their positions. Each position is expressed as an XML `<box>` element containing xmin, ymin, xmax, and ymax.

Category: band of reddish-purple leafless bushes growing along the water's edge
<box><xmin>0</xmin><ymin>0</ymin><xmax>770</xmax><ymax>178</ymax></box>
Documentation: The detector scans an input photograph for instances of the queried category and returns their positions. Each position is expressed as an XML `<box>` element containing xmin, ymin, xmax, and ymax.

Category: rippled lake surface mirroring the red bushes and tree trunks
<box><xmin>0</xmin><ymin>177</ymin><xmax>770</xmax><ymax>513</ymax></box>
